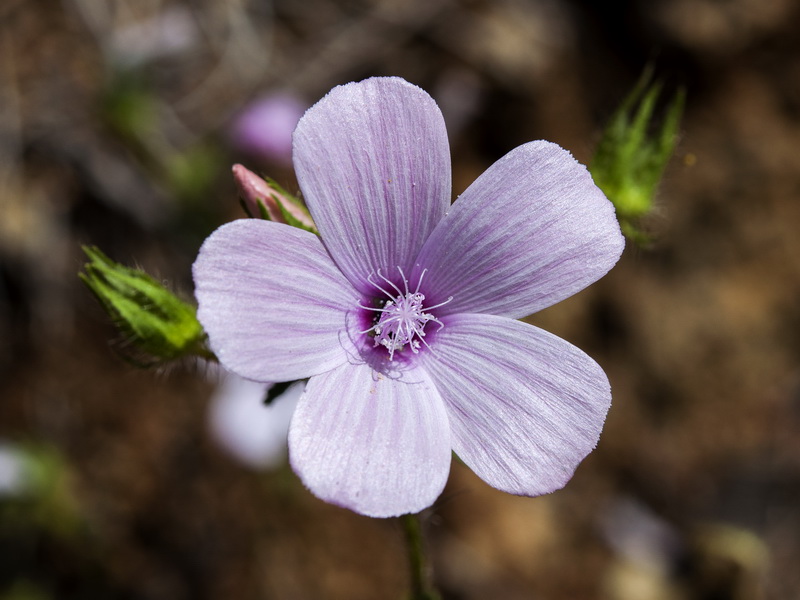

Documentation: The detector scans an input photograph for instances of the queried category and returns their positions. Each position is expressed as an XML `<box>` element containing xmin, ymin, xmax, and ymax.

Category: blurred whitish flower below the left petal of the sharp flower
<box><xmin>209</xmin><ymin>368</ymin><xmax>305</xmax><ymax>469</ymax></box>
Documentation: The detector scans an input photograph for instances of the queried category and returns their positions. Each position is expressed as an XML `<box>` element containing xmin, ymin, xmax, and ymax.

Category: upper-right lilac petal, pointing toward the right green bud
<box><xmin>417</xmin><ymin>141</ymin><xmax>624</xmax><ymax>318</ymax></box>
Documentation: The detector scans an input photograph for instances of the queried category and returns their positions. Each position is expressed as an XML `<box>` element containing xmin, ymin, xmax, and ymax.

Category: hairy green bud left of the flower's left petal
<box><xmin>78</xmin><ymin>246</ymin><xmax>208</xmax><ymax>364</ymax></box>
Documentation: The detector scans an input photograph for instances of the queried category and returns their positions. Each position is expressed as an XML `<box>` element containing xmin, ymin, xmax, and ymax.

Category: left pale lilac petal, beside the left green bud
<box><xmin>194</xmin><ymin>219</ymin><xmax>359</xmax><ymax>382</ymax></box>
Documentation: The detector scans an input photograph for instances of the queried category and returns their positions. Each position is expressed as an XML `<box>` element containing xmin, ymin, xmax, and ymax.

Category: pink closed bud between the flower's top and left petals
<box><xmin>233</xmin><ymin>165</ymin><xmax>316</xmax><ymax>231</ymax></box>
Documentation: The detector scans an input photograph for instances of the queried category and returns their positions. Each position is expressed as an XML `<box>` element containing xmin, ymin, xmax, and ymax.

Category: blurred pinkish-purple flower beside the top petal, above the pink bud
<box><xmin>230</xmin><ymin>92</ymin><xmax>308</xmax><ymax>166</ymax></box>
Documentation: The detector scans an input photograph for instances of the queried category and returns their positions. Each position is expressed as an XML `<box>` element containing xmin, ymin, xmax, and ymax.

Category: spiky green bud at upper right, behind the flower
<box><xmin>589</xmin><ymin>69</ymin><xmax>685</xmax><ymax>238</ymax></box>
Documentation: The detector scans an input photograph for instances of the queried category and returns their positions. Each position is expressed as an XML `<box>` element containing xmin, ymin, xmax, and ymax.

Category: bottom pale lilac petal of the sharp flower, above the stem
<box><xmin>289</xmin><ymin>364</ymin><xmax>450</xmax><ymax>517</ymax></box>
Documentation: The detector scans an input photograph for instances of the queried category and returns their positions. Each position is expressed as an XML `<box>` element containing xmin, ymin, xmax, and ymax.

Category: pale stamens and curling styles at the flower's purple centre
<box><xmin>361</xmin><ymin>267</ymin><xmax>453</xmax><ymax>360</ymax></box>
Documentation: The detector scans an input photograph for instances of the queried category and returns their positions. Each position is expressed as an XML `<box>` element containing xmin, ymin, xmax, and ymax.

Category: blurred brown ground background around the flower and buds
<box><xmin>0</xmin><ymin>0</ymin><xmax>800</xmax><ymax>600</ymax></box>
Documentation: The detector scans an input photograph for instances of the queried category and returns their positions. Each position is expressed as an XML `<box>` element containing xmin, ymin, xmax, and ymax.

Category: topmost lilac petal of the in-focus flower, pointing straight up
<box><xmin>294</xmin><ymin>78</ymin><xmax>450</xmax><ymax>292</ymax></box>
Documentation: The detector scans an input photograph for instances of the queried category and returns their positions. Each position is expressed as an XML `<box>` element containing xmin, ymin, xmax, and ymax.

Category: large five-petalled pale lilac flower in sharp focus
<box><xmin>194</xmin><ymin>78</ymin><xmax>624</xmax><ymax>517</ymax></box>
